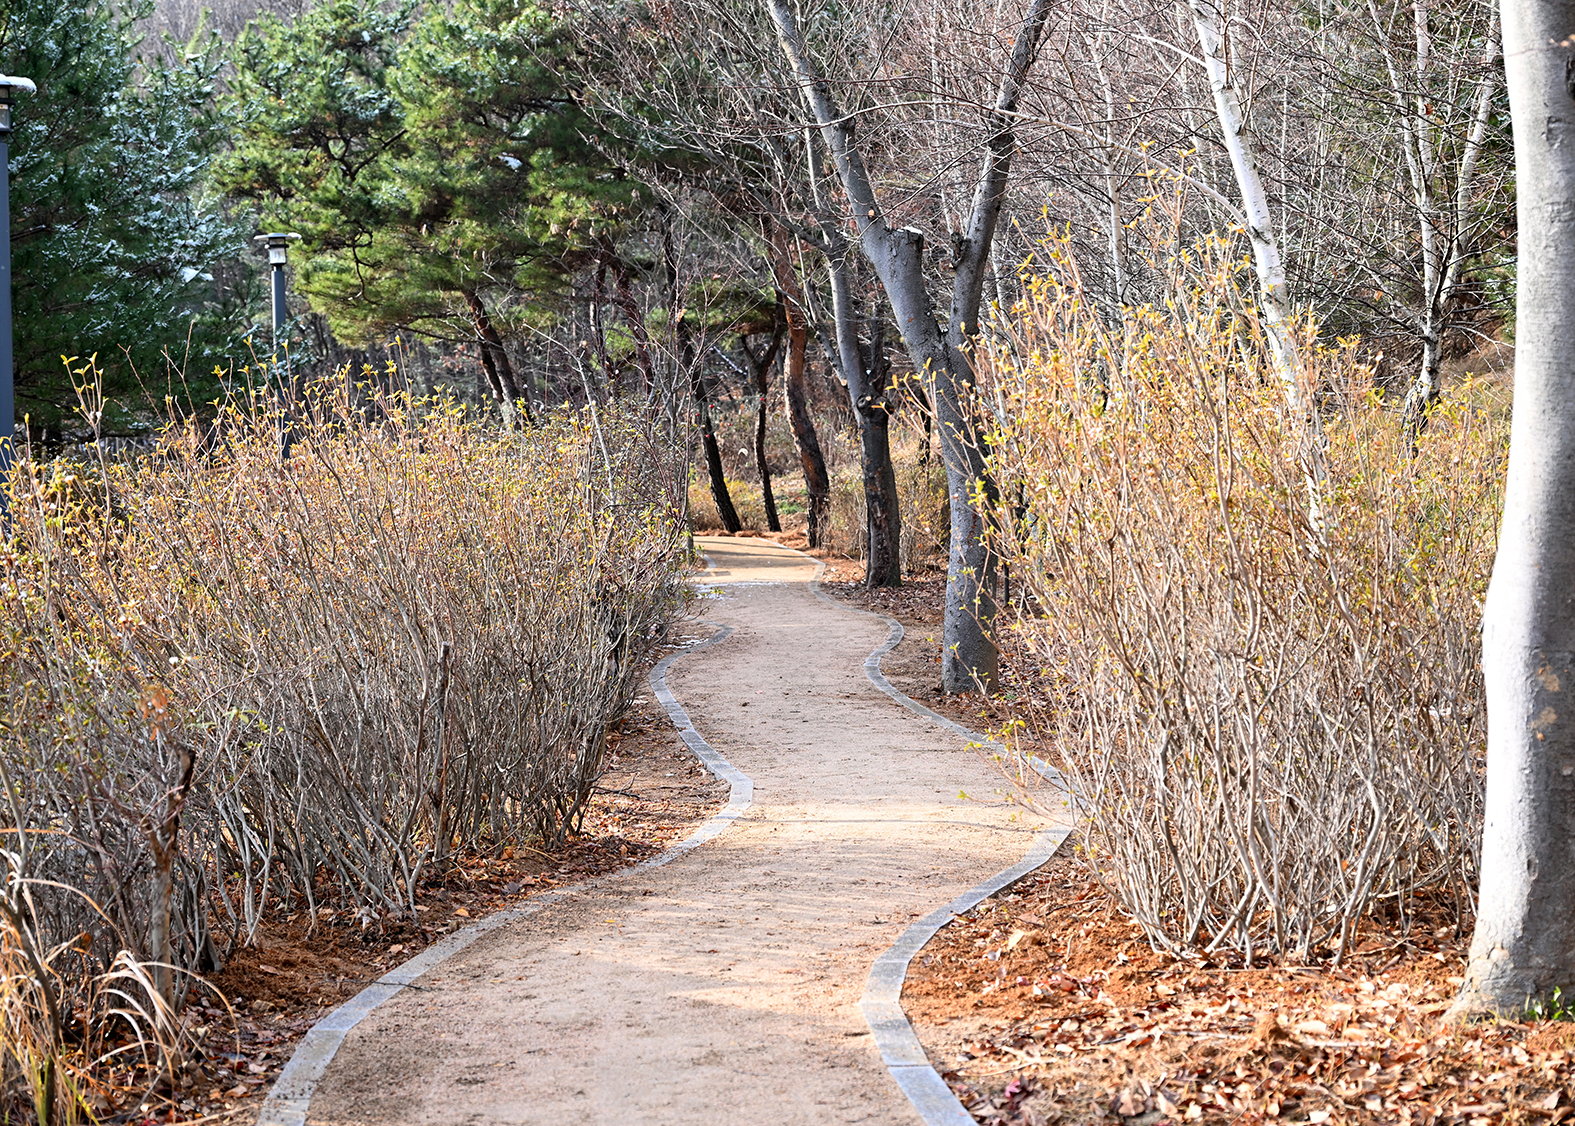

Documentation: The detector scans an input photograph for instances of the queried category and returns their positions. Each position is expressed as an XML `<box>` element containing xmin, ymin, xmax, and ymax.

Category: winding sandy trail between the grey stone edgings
<box><xmin>309</xmin><ymin>539</ymin><xmax>1043</xmax><ymax>1126</ymax></box>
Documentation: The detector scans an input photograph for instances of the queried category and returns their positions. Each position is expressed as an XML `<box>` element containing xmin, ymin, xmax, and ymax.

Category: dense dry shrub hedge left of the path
<box><xmin>0</xmin><ymin>365</ymin><xmax>685</xmax><ymax>1117</ymax></box>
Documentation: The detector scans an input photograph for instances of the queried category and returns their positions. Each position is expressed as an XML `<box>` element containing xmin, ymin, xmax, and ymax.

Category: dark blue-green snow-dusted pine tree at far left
<box><xmin>0</xmin><ymin>0</ymin><xmax>246</xmax><ymax>439</ymax></box>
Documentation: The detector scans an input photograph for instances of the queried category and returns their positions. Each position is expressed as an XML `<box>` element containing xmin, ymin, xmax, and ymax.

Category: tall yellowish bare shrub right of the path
<box><xmin>981</xmin><ymin>241</ymin><xmax>1507</xmax><ymax>961</ymax></box>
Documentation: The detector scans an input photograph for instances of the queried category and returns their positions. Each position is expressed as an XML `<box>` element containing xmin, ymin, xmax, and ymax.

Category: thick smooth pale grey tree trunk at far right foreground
<box><xmin>1454</xmin><ymin>0</ymin><xmax>1575</xmax><ymax>1016</ymax></box>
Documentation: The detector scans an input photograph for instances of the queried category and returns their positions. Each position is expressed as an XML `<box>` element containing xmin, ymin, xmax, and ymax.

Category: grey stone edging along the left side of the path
<box><xmin>257</xmin><ymin>625</ymin><xmax>746</xmax><ymax>1126</ymax></box>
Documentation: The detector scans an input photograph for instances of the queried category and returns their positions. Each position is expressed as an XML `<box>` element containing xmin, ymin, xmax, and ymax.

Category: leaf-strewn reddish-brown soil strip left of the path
<box><xmin>146</xmin><ymin>686</ymin><xmax>728</xmax><ymax>1123</ymax></box>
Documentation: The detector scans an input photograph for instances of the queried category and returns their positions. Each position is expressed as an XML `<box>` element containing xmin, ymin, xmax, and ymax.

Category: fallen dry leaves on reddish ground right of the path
<box><xmin>902</xmin><ymin>858</ymin><xmax>1575</xmax><ymax>1126</ymax></box>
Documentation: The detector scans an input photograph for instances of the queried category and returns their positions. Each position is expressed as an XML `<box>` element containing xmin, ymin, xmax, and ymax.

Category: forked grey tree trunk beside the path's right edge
<box><xmin>765</xmin><ymin>0</ymin><xmax>1051</xmax><ymax>693</ymax></box>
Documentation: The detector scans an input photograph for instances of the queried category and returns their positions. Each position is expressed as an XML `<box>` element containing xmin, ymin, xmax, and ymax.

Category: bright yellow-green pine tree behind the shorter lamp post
<box><xmin>219</xmin><ymin>0</ymin><xmax>638</xmax><ymax>416</ymax></box>
